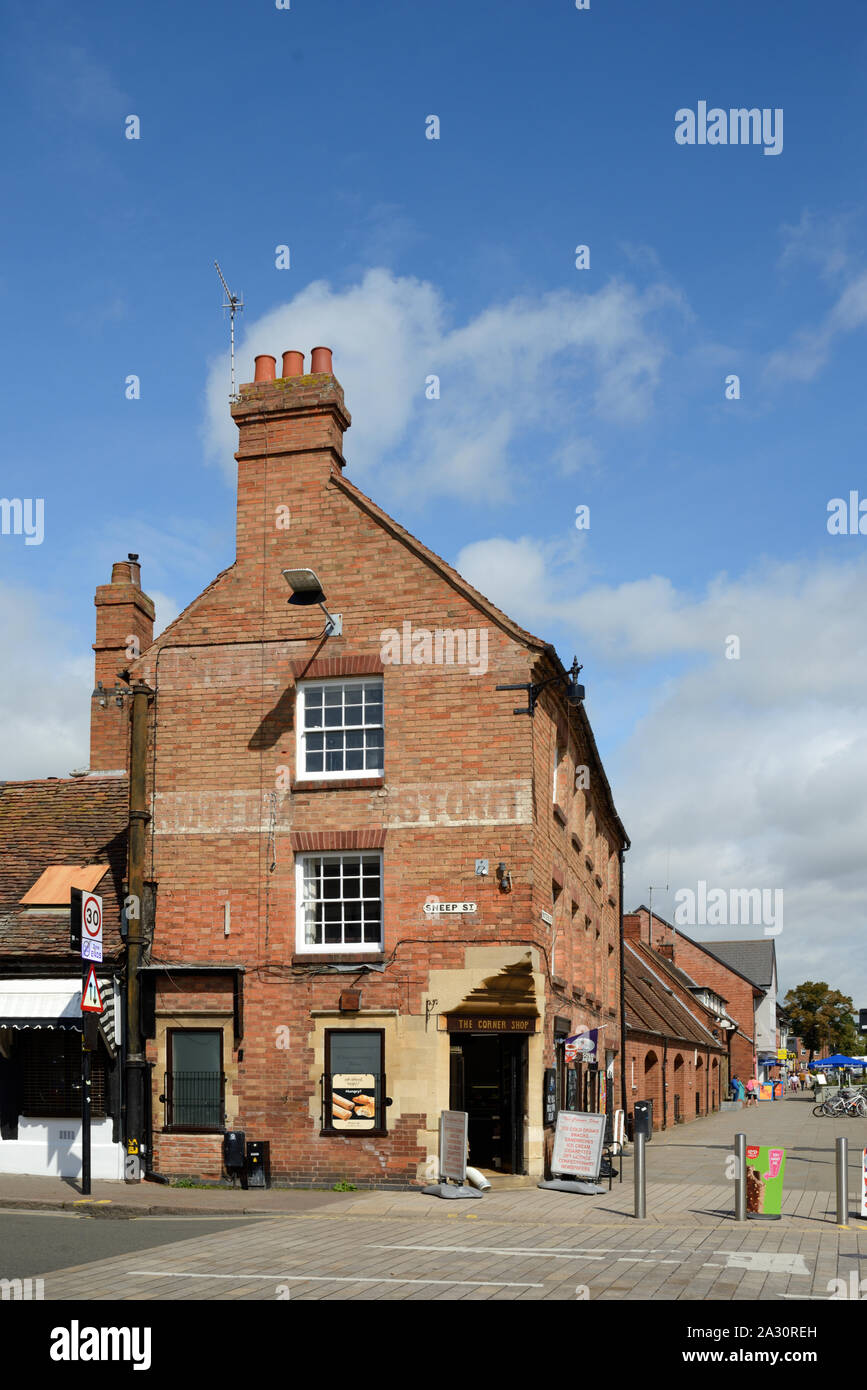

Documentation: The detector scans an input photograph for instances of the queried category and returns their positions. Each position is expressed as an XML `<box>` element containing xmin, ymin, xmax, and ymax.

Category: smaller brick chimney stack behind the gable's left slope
<box><xmin>90</xmin><ymin>555</ymin><xmax>154</xmax><ymax>771</ymax></box>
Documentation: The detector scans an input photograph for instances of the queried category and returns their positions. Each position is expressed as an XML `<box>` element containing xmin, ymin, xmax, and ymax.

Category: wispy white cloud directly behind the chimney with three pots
<box><xmin>206</xmin><ymin>270</ymin><xmax>684</xmax><ymax>502</ymax></box>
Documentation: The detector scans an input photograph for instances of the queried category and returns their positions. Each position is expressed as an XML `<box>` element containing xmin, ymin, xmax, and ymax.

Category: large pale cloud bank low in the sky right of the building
<box><xmin>457</xmin><ymin>537</ymin><xmax>867</xmax><ymax>1004</ymax></box>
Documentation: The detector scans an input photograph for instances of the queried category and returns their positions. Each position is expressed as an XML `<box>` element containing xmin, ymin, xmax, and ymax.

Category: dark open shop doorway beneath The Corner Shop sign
<box><xmin>449</xmin><ymin>1034</ymin><xmax>527</xmax><ymax>1173</ymax></box>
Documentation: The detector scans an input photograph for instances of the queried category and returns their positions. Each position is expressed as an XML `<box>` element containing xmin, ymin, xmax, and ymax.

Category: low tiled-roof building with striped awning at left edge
<box><xmin>0</xmin><ymin>778</ymin><xmax>129</xmax><ymax>1180</ymax></box>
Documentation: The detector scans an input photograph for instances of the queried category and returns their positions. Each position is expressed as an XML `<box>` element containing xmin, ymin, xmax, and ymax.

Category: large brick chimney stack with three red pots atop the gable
<box><xmin>232</xmin><ymin>348</ymin><xmax>352</xmax><ymax>569</ymax></box>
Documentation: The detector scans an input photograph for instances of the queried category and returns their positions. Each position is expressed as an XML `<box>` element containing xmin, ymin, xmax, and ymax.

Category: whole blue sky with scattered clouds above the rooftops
<box><xmin>0</xmin><ymin>0</ymin><xmax>867</xmax><ymax>1004</ymax></box>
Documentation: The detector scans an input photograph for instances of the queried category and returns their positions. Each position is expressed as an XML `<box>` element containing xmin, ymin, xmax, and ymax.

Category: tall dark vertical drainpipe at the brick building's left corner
<box><xmin>124</xmin><ymin>681</ymin><xmax>153</xmax><ymax>1182</ymax></box>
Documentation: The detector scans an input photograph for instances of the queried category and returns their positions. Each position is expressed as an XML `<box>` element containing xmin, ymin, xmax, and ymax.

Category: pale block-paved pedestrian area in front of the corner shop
<box><xmin>0</xmin><ymin>1099</ymin><xmax>867</xmax><ymax>1304</ymax></box>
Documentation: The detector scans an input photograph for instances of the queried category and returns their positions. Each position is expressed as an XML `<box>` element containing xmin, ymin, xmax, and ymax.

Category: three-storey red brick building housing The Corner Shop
<box><xmin>118</xmin><ymin>349</ymin><xmax>628</xmax><ymax>1184</ymax></box>
